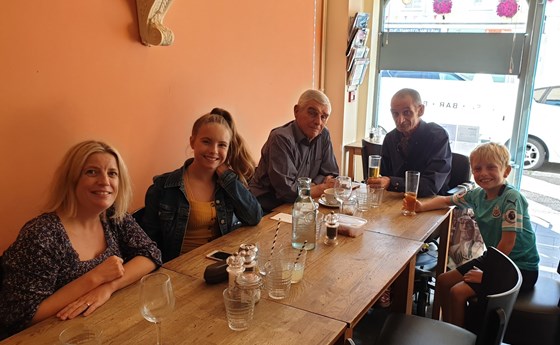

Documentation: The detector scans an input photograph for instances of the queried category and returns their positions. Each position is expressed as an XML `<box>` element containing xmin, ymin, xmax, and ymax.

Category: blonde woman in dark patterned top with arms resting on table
<box><xmin>0</xmin><ymin>141</ymin><xmax>161</xmax><ymax>337</ymax></box>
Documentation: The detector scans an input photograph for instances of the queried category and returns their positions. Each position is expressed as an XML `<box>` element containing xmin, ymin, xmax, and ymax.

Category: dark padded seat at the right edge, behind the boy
<box><xmin>513</xmin><ymin>277</ymin><xmax>560</xmax><ymax>314</ymax></box>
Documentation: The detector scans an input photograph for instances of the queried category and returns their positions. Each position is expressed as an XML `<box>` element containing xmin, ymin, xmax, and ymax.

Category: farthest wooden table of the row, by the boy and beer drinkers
<box><xmin>334</xmin><ymin>191</ymin><xmax>453</xmax><ymax>319</ymax></box>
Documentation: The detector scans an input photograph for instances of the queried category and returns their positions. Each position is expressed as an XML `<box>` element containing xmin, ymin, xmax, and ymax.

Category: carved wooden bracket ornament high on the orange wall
<box><xmin>136</xmin><ymin>0</ymin><xmax>174</xmax><ymax>46</ymax></box>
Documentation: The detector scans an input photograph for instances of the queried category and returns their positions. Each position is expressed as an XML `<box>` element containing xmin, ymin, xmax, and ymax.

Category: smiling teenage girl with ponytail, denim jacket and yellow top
<box><xmin>141</xmin><ymin>108</ymin><xmax>263</xmax><ymax>262</ymax></box>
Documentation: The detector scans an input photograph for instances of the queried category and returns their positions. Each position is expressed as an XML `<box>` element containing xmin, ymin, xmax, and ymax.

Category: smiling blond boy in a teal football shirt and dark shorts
<box><xmin>414</xmin><ymin>143</ymin><xmax>539</xmax><ymax>326</ymax></box>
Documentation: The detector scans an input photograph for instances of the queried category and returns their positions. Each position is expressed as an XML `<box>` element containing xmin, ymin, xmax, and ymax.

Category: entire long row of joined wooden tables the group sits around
<box><xmin>0</xmin><ymin>192</ymin><xmax>451</xmax><ymax>345</ymax></box>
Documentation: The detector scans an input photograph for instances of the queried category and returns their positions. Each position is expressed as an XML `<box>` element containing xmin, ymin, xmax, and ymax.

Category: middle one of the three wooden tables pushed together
<box><xmin>164</xmin><ymin>206</ymin><xmax>422</xmax><ymax>337</ymax></box>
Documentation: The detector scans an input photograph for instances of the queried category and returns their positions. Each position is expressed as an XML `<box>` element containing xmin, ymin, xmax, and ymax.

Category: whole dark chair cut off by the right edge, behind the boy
<box><xmin>504</xmin><ymin>262</ymin><xmax>560</xmax><ymax>345</ymax></box>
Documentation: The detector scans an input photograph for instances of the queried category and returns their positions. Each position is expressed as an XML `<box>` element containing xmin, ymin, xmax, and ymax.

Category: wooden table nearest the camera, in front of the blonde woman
<box><xmin>0</xmin><ymin>268</ymin><xmax>346</xmax><ymax>345</ymax></box>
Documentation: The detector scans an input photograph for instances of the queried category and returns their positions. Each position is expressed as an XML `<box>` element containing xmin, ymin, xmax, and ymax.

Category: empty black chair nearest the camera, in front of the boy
<box><xmin>376</xmin><ymin>247</ymin><xmax>522</xmax><ymax>345</ymax></box>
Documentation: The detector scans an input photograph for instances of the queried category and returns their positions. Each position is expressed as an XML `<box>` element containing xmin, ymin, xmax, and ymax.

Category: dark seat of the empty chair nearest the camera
<box><xmin>376</xmin><ymin>314</ymin><xmax>476</xmax><ymax>345</ymax></box>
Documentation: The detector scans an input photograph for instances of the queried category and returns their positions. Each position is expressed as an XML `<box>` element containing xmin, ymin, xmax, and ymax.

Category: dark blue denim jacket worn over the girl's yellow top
<box><xmin>140</xmin><ymin>158</ymin><xmax>263</xmax><ymax>262</ymax></box>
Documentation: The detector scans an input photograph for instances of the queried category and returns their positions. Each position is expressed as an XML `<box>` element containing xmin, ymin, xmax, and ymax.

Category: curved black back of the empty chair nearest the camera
<box><xmin>476</xmin><ymin>247</ymin><xmax>523</xmax><ymax>345</ymax></box>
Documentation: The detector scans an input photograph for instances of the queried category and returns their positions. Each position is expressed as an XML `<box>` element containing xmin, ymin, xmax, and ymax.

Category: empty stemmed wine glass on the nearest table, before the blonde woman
<box><xmin>140</xmin><ymin>272</ymin><xmax>175</xmax><ymax>345</ymax></box>
